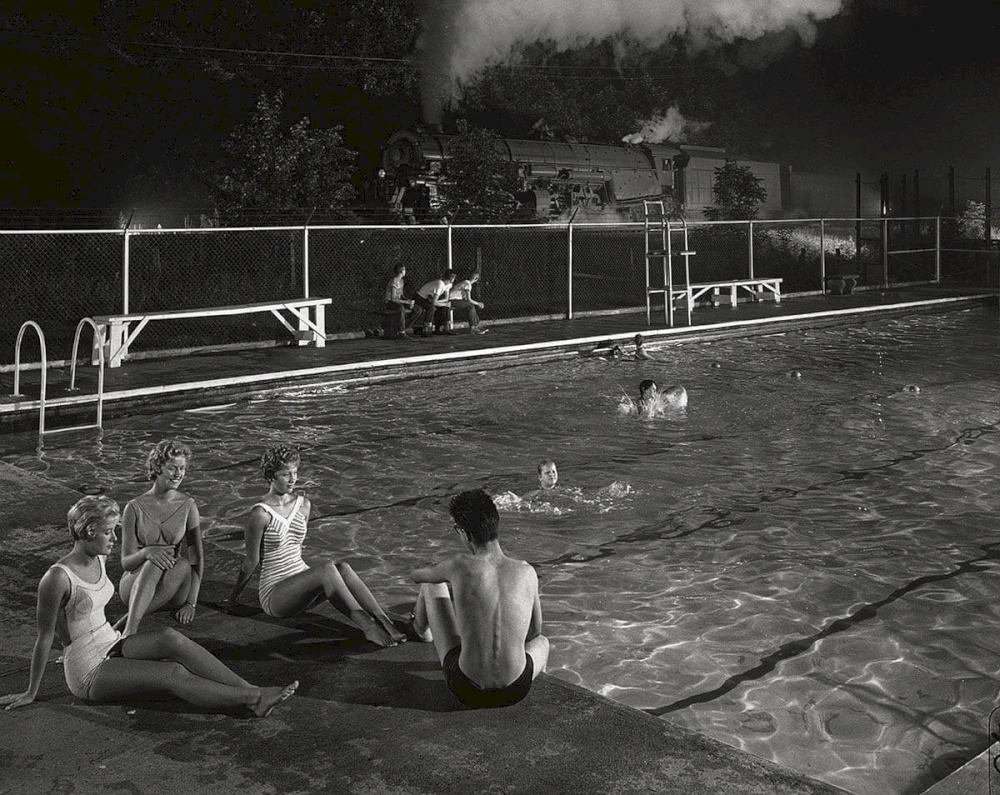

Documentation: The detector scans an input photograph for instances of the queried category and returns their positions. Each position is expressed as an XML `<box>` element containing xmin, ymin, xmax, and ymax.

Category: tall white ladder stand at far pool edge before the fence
<box><xmin>643</xmin><ymin>201</ymin><xmax>695</xmax><ymax>327</ymax></box>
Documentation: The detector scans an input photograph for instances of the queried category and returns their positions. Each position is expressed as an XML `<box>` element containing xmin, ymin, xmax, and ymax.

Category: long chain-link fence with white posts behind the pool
<box><xmin>0</xmin><ymin>218</ymin><xmax>997</xmax><ymax>365</ymax></box>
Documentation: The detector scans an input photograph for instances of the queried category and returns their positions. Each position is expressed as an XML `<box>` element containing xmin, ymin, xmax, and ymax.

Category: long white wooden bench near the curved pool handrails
<box><xmin>92</xmin><ymin>298</ymin><xmax>333</xmax><ymax>367</ymax></box>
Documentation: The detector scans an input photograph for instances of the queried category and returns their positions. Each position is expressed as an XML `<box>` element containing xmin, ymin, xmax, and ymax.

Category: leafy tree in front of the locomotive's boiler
<box><xmin>439</xmin><ymin>121</ymin><xmax>520</xmax><ymax>221</ymax></box>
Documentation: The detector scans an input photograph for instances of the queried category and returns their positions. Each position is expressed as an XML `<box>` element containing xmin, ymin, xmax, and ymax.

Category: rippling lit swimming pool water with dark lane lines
<box><xmin>0</xmin><ymin>308</ymin><xmax>1000</xmax><ymax>795</ymax></box>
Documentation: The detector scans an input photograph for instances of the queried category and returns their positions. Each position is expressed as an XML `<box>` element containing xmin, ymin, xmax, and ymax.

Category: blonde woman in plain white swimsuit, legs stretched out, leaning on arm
<box><xmin>0</xmin><ymin>495</ymin><xmax>299</xmax><ymax>717</ymax></box>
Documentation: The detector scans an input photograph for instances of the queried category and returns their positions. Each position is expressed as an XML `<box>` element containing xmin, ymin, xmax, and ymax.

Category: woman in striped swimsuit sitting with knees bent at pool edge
<box><xmin>230</xmin><ymin>445</ymin><xmax>406</xmax><ymax>646</ymax></box>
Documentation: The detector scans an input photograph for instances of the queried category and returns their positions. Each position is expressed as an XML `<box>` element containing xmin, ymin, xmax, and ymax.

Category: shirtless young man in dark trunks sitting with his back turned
<box><xmin>410</xmin><ymin>489</ymin><xmax>549</xmax><ymax>708</ymax></box>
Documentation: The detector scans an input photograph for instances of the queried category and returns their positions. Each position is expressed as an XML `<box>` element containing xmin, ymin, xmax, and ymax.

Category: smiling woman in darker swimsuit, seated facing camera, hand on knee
<box><xmin>118</xmin><ymin>441</ymin><xmax>205</xmax><ymax>635</ymax></box>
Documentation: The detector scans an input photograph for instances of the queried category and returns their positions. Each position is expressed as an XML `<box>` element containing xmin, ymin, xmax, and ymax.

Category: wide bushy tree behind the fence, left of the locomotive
<box><xmin>210</xmin><ymin>91</ymin><xmax>357</xmax><ymax>220</ymax></box>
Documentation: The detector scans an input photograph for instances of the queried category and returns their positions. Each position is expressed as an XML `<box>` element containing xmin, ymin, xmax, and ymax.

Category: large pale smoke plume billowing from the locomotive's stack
<box><xmin>421</xmin><ymin>0</ymin><xmax>844</xmax><ymax>124</ymax></box>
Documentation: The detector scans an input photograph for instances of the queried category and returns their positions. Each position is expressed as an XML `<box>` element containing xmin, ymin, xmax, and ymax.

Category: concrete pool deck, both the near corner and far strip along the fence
<box><xmin>0</xmin><ymin>288</ymin><xmax>996</xmax><ymax>795</ymax></box>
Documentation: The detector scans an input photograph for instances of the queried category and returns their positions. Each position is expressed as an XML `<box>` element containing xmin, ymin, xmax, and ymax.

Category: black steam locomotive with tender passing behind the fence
<box><xmin>382</xmin><ymin>130</ymin><xmax>781</xmax><ymax>222</ymax></box>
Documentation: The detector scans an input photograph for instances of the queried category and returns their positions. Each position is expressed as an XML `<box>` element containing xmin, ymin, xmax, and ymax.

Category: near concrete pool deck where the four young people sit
<box><xmin>0</xmin><ymin>464</ymin><xmax>841</xmax><ymax>795</ymax></box>
